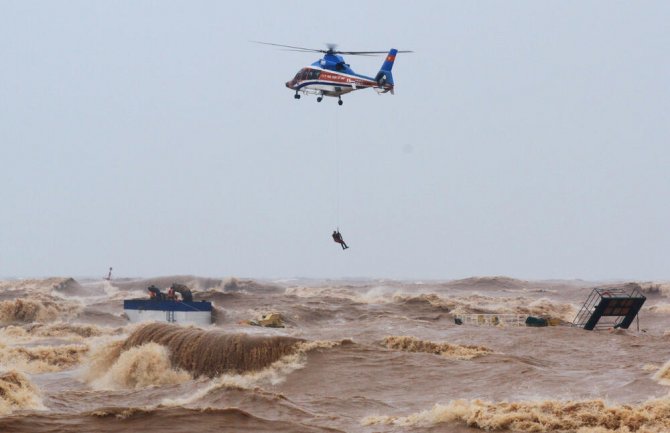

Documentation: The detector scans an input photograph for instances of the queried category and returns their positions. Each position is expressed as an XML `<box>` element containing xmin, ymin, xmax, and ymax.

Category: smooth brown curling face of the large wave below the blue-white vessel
<box><xmin>122</xmin><ymin>323</ymin><xmax>302</xmax><ymax>377</ymax></box>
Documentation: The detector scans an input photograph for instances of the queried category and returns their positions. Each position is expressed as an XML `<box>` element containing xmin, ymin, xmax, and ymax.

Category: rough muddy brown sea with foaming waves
<box><xmin>0</xmin><ymin>276</ymin><xmax>670</xmax><ymax>433</ymax></box>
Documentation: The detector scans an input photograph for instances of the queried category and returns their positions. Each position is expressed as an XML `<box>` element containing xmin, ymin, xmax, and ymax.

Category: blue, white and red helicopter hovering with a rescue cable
<box><xmin>252</xmin><ymin>41</ymin><xmax>413</xmax><ymax>105</ymax></box>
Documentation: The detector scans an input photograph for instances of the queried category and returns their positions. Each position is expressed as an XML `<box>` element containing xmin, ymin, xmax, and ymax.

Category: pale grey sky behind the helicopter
<box><xmin>0</xmin><ymin>1</ymin><xmax>670</xmax><ymax>279</ymax></box>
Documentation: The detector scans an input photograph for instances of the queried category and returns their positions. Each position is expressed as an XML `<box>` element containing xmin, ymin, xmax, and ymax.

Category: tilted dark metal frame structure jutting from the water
<box><xmin>572</xmin><ymin>287</ymin><xmax>647</xmax><ymax>331</ymax></box>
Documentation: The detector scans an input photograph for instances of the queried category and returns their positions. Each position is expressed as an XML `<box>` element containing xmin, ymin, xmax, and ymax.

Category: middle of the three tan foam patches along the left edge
<box><xmin>0</xmin><ymin>343</ymin><xmax>88</xmax><ymax>373</ymax></box>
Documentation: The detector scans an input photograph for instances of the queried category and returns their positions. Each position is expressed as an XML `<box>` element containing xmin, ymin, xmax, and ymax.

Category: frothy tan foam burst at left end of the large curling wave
<box><xmin>84</xmin><ymin>341</ymin><xmax>191</xmax><ymax>390</ymax></box>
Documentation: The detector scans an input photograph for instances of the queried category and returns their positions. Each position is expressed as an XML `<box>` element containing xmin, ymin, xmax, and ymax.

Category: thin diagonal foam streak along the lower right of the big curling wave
<box><xmin>161</xmin><ymin>340</ymin><xmax>352</xmax><ymax>406</ymax></box>
